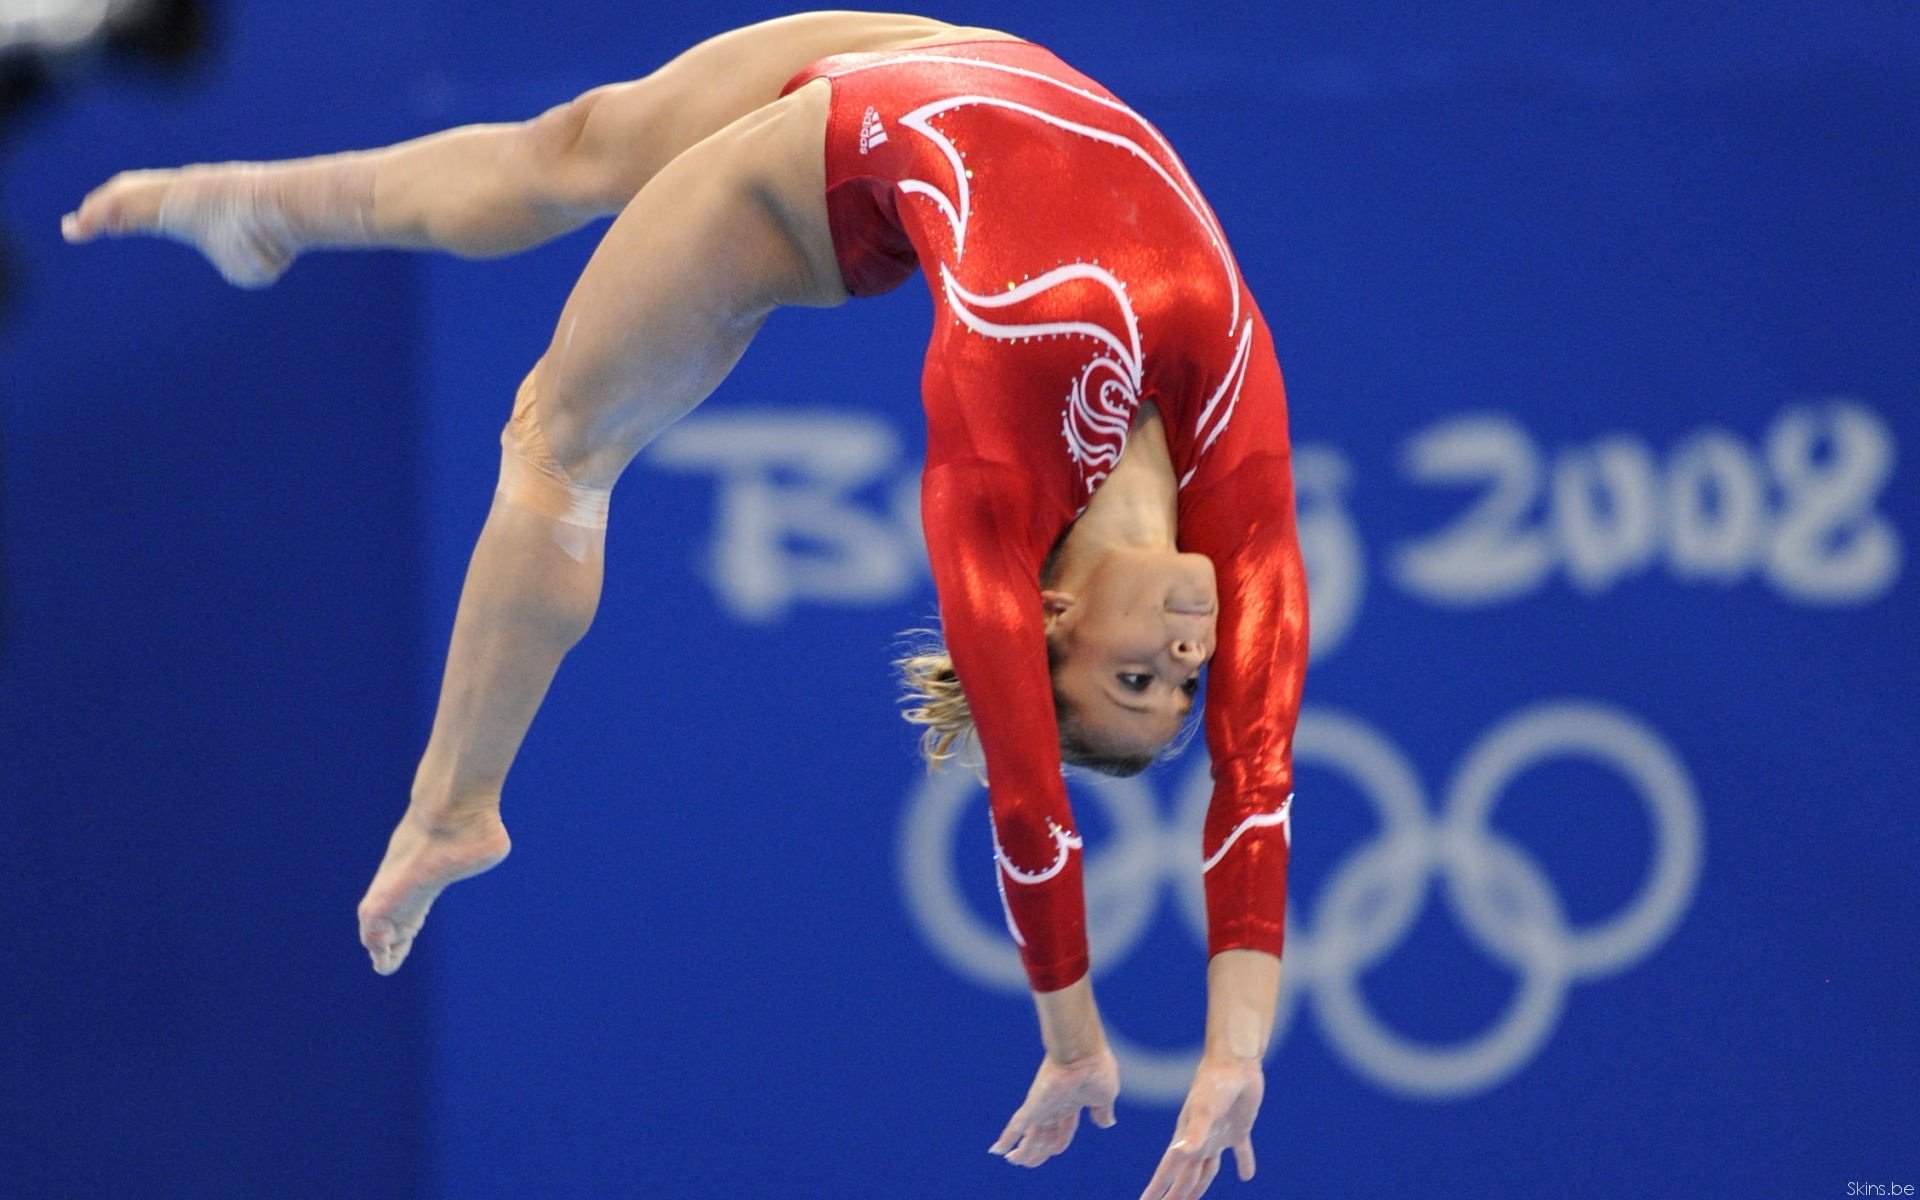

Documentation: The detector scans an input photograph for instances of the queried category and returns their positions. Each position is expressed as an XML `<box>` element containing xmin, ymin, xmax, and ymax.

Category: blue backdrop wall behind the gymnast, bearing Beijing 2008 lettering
<box><xmin>0</xmin><ymin>2</ymin><xmax>1920</xmax><ymax>1196</ymax></box>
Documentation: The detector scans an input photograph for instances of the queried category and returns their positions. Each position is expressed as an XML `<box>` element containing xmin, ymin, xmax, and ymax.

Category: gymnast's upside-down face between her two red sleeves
<box><xmin>1041</xmin><ymin>549</ymin><xmax>1219</xmax><ymax>756</ymax></box>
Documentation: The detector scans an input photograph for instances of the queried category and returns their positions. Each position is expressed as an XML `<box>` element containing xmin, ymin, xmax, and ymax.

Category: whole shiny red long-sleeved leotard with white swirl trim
<box><xmin>787</xmin><ymin>40</ymin><xmax>1308</xmax><ymax>991</ymax></box>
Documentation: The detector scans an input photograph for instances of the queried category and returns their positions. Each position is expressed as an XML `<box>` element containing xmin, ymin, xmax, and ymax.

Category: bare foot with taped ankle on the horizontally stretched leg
<box><xmin>60</xmin><ymin>163</ymin><xmax>300</xmax><ymax>288</ymax></box>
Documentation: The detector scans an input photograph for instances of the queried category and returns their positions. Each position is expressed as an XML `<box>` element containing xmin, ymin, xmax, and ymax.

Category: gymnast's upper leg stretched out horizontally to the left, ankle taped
<box><xmin>61</xmin><ymin>12</ymin><xmax>967</xmax><ymax>288</ymax></box>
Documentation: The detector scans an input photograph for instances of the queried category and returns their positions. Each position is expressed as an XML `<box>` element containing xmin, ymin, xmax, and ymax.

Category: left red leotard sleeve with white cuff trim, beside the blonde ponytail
<box><xmin>920</xmin><ymin>459</ymin><xmax>1087</xmax><ymax>991</ymax></box>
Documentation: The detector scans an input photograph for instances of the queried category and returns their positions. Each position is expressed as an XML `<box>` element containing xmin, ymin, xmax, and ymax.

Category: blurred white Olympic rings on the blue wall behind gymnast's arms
<box><xmin>899</xmin><ymin>701</ymin><xmax>1701</xmax><ymax>1104</ymax></box>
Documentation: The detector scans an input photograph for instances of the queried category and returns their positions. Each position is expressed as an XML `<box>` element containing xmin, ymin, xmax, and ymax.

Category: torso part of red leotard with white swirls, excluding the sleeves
<box><xmin>785</xmin><ymin>38</ymin><xmax>1284</xmax><ymax>515</ymax></box>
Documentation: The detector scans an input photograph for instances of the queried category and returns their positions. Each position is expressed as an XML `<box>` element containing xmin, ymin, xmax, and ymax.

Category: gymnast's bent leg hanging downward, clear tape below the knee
<box><xmin>359</xmin><ymin>83</ymin><xmax>845</xmax><ymax>973</ymax></box>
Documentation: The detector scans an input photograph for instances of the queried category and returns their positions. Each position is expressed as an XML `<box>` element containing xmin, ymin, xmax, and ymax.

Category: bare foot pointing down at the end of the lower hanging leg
<box><xmin>359</xmin><ymin>808</ymin><xmax>513</xmax><ymax>975</ymax></box>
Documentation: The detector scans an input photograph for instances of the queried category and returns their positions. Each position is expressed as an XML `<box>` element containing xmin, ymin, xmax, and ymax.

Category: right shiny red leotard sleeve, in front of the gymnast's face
<box><xmin>1181</xmin><ymin>369</ymin><xmax>1308</xmax><ymax>954</ymax></box>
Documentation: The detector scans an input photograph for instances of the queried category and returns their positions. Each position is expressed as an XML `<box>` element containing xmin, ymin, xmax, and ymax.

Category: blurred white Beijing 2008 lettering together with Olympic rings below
<box><xmin>647</xmin><ymin>399</ymin><xmax>1903</xmax><ymax>1104</ymax></box>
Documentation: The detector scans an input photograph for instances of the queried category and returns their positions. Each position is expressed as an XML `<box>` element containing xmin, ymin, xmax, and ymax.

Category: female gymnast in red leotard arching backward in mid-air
<box><xmin>63</xmin><ymin>12</ymin><xmax>1308</xmax><ymax>1200</ymax></box>
